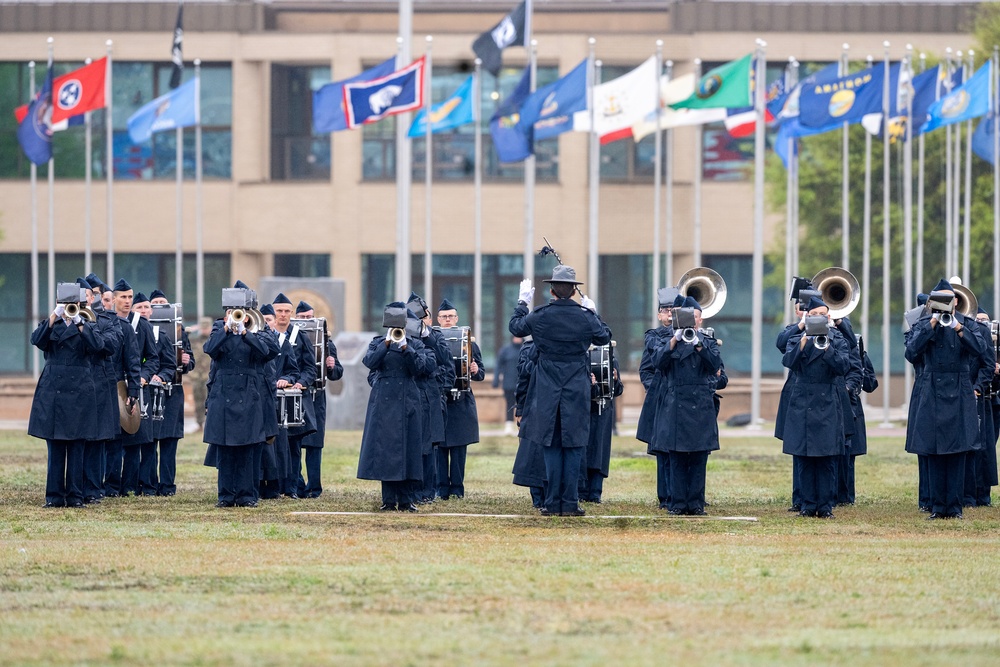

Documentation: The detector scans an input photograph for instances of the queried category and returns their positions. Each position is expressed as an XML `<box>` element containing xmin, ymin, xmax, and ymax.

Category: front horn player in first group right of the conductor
<box><xmin>653</xmin><ymin>296</ymin><xmax>722</xmax><ymax>515</ymax></box>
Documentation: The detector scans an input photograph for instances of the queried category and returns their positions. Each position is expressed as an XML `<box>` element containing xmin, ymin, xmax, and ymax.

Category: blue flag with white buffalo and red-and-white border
<box><xmin>344</xmin><ymin>57</ymin><xmax>427</xmax><ymax>129</ymax></box>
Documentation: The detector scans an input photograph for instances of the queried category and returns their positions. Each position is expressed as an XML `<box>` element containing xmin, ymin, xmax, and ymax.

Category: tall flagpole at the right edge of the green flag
<box><xmin>752</xmin><ymin>39</ymin><xmax>767</xmax><ymax>430</ymax></box>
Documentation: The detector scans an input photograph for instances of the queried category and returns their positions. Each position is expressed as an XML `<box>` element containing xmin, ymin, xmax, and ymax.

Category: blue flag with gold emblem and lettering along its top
<box><xmin>799</xmin><ymin>63</ymin><xmax>900</xmax><ymax>127</ymax></box>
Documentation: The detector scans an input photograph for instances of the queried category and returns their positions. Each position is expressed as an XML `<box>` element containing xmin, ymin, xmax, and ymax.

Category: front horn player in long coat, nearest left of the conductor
<box><xmin>358</xmin><ymin>301</ymin><xmax>437</xmax><ymax>512</ymax></box>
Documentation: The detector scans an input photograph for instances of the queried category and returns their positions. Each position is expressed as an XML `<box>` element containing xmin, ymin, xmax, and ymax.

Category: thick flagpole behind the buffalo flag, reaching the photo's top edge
<box><xmin>396</xmin><ymin>0</ymin><xmax>412</xmax><ymax>300</ymax></box>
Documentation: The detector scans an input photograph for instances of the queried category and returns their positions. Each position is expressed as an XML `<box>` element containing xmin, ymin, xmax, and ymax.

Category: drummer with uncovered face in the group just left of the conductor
<box><xmin>437</xmin><ymin>299</ymin><xmax>486</xmax><ymax>500</ymax></box>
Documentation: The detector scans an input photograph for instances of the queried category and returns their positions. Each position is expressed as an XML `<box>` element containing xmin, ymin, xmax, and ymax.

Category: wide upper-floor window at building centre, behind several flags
<box><xmin>362</xmin><ymin>66</ymin><xmax>559</xmax><ymax>182</ymax></box>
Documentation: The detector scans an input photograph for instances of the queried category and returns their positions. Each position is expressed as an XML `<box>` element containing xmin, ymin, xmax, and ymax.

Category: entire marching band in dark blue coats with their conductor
<box><xmin>21</xmin><ymin>256</ymin><xmax>1000</xmax><ymax>519</ymax></box>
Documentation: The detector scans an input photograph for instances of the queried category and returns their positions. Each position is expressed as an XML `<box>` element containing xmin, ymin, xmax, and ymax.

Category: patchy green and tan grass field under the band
<box><xmin>0</xmin><ymin>432</ymin><xmax>1000</xmax><ymax>666</ymax></box>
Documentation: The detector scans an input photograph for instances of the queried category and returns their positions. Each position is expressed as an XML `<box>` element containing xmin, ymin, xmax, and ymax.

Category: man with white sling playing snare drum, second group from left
<box><xmin>271</xmin><ymin>293</ymin><xmax>316</xmax><ymax>498</ymax></box>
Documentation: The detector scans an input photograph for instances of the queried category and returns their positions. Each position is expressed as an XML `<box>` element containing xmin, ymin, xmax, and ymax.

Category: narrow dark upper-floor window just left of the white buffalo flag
<box><xmin>271</xmin><ymin>64</ymin><xmax>331</xmax><ymax>181</ymax></box>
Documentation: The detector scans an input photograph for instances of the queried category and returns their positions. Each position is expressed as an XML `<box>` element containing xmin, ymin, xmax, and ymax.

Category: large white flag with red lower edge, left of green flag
<box><xmin>573</xmin><ymin>56</ymin><xmax>659</xmax><ymax>144</ymax></box>
